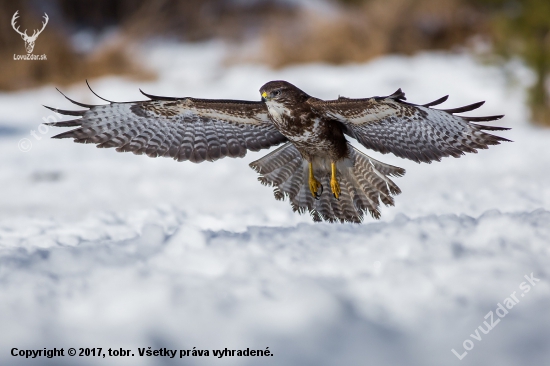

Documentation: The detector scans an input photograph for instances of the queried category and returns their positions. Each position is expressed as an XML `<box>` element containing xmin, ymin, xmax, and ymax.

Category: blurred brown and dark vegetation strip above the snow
<box><xmin>0</xmin><ymin>0</ymin><xmax>550</xmax><ymax>126</ymax></box>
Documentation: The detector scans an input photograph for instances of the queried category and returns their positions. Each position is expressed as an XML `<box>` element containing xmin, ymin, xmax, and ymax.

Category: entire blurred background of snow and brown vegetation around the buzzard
<box><xmin>0</xmin><ymin>0</ymin><xmax>550</xmax><ymax>366</ymax></box>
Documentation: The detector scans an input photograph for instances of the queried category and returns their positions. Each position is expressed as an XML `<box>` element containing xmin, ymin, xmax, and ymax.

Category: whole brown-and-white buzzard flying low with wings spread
<box><xmin>47</xmin><ymin>81</ymin><xmax>509</xmax><ymax>223</ymax></box>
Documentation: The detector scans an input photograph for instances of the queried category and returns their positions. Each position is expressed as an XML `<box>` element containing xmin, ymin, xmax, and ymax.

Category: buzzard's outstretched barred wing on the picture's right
<box><xmin>310</xmin><ymin>89</ymin><xmax>510</xmax><ymax>163</ymax></box>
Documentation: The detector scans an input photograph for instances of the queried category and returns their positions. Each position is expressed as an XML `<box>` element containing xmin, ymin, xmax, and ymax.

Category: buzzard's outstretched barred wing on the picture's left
<box><xmin>46</xmin><ymin>88</ymin><xmax>287</xmax><ymax>163</ymax></box>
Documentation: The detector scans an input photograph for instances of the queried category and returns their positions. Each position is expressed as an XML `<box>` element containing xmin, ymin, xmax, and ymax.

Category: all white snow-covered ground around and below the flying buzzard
<box><xmin>0</xmin><ymin>43</ymin><xmax>550</xmax><ymax>365</ymax></box>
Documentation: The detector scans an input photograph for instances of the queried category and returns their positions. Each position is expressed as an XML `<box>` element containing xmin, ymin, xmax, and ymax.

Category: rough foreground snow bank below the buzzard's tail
<box><xmin>0</xmin><ymin>209</ymin><xmax>550</xmax><ymax>365</ymax></box>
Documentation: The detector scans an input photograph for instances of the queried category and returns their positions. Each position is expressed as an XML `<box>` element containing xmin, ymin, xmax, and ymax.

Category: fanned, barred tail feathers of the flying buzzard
<box><xmin>250</xmin><ymin>143</ymin><xmax>405</xmax><ymax>223</ymax></box>
